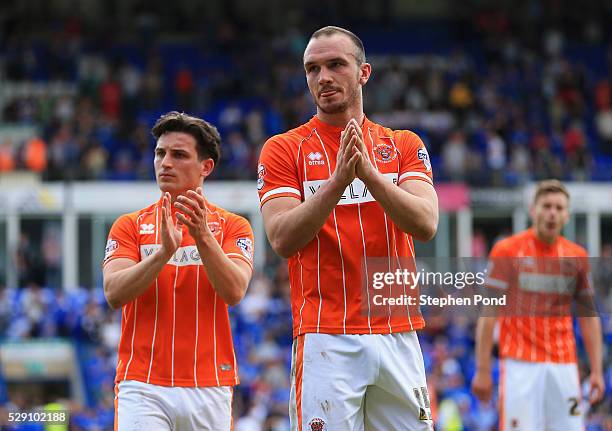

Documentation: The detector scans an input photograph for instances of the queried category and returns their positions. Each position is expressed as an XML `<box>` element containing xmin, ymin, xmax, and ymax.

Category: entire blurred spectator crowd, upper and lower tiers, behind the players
<box><xmin>0</xmin><ymin>0</ymin><xmax>612</xmax><ymax>431</ymax></box>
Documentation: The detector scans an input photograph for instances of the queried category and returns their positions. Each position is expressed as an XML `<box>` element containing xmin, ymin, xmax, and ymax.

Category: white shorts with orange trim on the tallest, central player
<box><xmin>289</xmin><ymin>331</ymin><xmax>433</xmax><ymax>431</ymax></box>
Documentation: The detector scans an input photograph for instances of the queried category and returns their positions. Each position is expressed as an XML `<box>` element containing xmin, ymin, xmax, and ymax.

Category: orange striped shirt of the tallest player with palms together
<box><xmin>257</xmin><ymin>116</ymin><xmax>433</xmax><ymax>337</ymax></box>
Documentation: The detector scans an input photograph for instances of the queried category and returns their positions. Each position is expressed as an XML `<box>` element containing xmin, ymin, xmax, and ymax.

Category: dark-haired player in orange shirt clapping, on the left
<box><xmin>104</xmin><ymin>112</ymin><xmax>253</xmax><ymax>431</ymax></box>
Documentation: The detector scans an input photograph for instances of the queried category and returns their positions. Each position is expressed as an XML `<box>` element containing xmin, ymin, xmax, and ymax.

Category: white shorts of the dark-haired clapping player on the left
<box><xmin>115</xmin><ymin>380</ymin><xmax>234</xmax><ymax>431</ymax></box>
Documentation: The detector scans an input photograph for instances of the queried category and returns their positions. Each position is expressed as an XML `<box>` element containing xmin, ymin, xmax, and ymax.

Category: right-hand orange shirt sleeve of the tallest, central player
<box><xmin>395</xmin><ymin>130</ymin><xmax>433</xmax><ymax>185</ymax></box>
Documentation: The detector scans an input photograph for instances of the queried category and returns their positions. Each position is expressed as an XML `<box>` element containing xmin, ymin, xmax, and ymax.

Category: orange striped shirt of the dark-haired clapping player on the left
<box><xmin>104</xmin><ymin>199</ymin><xmax>253</xmax><ymax>387</ymax></box>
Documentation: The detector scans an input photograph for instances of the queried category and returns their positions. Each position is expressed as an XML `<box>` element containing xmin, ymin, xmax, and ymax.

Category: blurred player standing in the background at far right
<box><xmin>472</xmin><ymin>180</ymin><xmax>604</xmax><ymax>431</ymax></box>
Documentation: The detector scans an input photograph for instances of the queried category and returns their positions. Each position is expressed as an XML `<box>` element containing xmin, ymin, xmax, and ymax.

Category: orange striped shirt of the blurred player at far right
<box><xmin>487</xmin><ymin>228</ymin><xmax>591</xmax><ymax>363</ymax></box>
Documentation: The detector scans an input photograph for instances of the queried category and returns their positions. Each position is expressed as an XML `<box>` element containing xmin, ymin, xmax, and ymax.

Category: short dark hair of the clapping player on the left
<box><xmin>151</xmin><ymin>111</ymin><xmax>221</xmax><ymax>165</ymax></box>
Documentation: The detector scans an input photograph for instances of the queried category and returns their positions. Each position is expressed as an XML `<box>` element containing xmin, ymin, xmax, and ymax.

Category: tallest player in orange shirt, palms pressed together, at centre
<box><xmin>258</xmin><ymin>27</ymin><xmax>438</xmax><ymax>431</ymax></box>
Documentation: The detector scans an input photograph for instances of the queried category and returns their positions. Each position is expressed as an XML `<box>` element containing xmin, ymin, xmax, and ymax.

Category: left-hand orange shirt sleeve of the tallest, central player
<box><xmin>257</xmin><ymin>137</ymin><xmax>303</xmax><ymax>206</ymax></box>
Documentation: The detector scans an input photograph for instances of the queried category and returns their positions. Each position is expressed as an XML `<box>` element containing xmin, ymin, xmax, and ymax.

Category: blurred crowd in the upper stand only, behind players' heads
<box><xmin>0</xmin><ymin>2</ymin><xmax>612</xmax><ymax>186</ymax></box>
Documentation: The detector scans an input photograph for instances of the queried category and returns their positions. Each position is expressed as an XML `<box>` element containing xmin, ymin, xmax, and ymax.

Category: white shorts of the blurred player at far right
<box><xmin>499</xmin><ymin>359</ymin><xmax>584</xmax><ymax>431</ymax></box>
